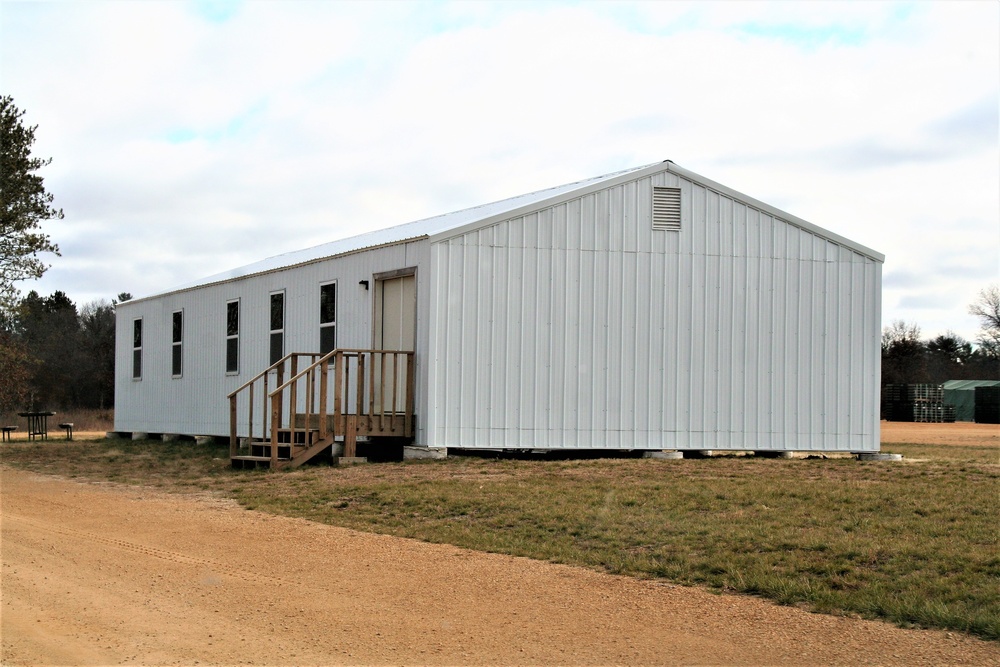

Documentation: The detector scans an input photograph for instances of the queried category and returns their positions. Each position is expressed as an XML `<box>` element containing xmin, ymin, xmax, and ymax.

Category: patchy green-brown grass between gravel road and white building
<box><xmin>0</xmin><ymin>440</ymin><xmax>1000</xmax><ymax>641</ymax></box>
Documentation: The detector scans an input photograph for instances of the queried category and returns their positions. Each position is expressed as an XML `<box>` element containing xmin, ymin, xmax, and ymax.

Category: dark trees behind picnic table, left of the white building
<box><xmin>0</xmin><ymin>291</ymin><xmax>131</xmax><ymax>412</ymax></box>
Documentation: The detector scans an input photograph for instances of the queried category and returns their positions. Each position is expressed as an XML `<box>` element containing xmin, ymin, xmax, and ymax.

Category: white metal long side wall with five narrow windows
<box><xmin>115</xmin><ymin>241</ymin><xmax>429</xmax><ymax>441</ymax></box>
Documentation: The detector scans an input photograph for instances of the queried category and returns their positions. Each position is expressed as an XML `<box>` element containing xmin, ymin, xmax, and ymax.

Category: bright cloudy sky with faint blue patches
<box><xmin>0</xmin><ymin>0</ymin><xmax>1000</xmax><ymax>339</ymax></box>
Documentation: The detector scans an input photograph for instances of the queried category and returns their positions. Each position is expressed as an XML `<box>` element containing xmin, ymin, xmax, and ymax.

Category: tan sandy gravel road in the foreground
<box><xmin>0</xmin><ymin>467</ymin><xmax>1000</xmax><ymax>665</ymax></box>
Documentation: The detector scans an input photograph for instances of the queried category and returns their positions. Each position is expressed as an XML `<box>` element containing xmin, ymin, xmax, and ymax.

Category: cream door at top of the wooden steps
<box><xmin>372</xmin><ymin>275</ymin><xmax>417</xmax><ymax>412</ymax></box>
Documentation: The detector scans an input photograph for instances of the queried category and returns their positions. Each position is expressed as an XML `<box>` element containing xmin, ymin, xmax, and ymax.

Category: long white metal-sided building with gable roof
<box><xmin>115</xmin><ymin>161</ymin><xmax>884</xmax><ymax>464</ymax></box>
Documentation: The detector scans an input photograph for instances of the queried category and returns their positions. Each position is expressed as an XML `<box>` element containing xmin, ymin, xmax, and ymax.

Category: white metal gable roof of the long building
<box><xmin>134</xmin><ymin>160</ymin><xmax>885</xmax><ymax>301</ymax></box>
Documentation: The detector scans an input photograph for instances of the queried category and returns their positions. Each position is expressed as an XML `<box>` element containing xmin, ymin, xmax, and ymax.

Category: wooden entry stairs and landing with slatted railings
<box><xmin>229</xmin><ymin>350</ymin><xmax>416</xmax><ymax>469</ymax></box>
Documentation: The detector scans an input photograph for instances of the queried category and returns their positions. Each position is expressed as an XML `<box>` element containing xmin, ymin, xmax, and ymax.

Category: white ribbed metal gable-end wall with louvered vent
<box><xmin>426</xmin><ymin>172</ymin><xmax>881</xmax><ymax>451</ymax></box>
